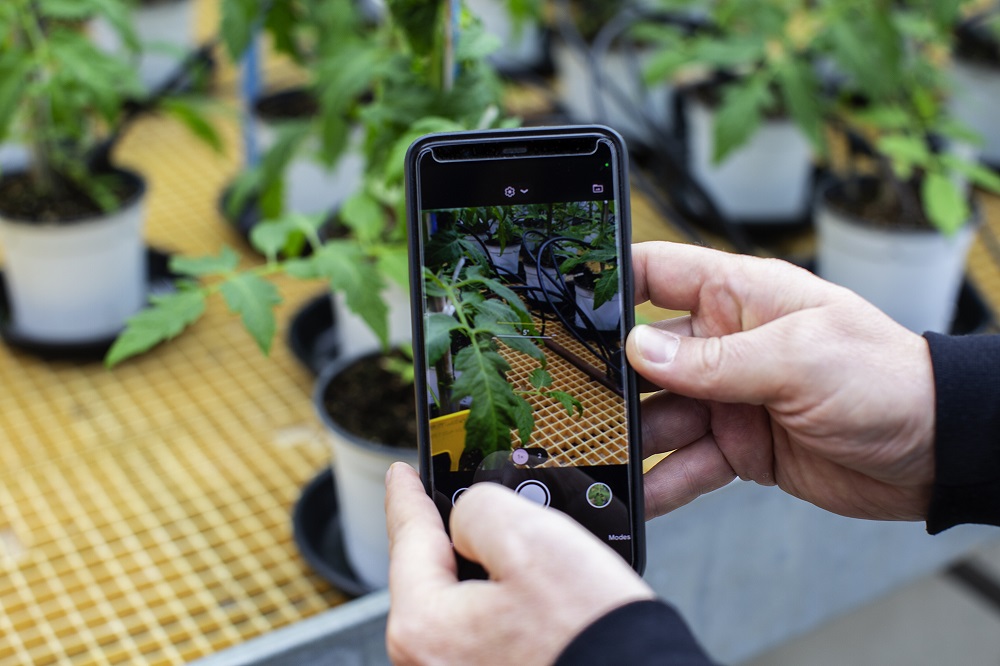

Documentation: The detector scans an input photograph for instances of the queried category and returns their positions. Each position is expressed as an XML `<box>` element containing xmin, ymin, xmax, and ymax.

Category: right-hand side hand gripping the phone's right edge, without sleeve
<box><xmin>626</xmin><ymin>242</ymin><xmax>935</xmax><ymax>520</ymax></box>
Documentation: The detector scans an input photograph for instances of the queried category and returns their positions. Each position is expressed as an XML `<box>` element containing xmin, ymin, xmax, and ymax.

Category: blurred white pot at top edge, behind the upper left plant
<box><xmin>90</xmin><ymin>0</ymin><xmax>197</xmax><ymax>90</ymax></box>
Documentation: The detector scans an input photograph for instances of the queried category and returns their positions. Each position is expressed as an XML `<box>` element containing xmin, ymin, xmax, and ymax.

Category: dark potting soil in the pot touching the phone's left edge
<box><xmin>323</xmin><ymin>355</ymin><xmax>417</xmax><ymax>448</ymax></box>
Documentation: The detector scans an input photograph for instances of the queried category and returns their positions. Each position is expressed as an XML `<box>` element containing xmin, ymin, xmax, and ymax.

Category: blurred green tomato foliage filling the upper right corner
<box><xmin>644</xmin><ymin>0</ymin><xmax>1000</xmax><ymax>233</ymax></box>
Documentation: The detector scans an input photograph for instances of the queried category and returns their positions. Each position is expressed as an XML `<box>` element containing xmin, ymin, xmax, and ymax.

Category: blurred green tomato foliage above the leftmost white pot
<box><xmin>0</xmin><ymin>0</ymin><xmax>221</xmax><ymax>209</ymax></box>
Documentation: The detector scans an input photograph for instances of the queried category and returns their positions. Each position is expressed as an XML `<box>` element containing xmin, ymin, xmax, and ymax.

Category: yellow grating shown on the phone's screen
<box><xmin>500</xmin><ymin>321</ymin><xmax>628</xmax><ymax>467</ymax></box>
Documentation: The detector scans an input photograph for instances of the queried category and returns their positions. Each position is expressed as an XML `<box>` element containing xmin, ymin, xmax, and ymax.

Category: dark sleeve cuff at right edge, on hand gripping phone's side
<box><xmin>924</xmin><ymin>333</ymin><xmax>1000</xmax><ymax>534</ymax></box>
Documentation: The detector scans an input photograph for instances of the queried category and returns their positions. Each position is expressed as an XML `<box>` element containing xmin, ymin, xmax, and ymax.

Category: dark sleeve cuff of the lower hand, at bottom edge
<box><xmin>556</xmin><ymin>600</ymin><xmax>712</xmax><ymax>666</ymax></box>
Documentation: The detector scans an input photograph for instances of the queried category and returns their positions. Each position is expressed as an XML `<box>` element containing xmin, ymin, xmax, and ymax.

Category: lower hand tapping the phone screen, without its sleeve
<box><xmin>386</xmin><ymin>463</ymin><xmax>653</xmax><ymax>666</ymax></box>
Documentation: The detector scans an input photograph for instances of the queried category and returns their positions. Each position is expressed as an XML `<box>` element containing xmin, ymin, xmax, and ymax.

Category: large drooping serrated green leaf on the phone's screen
<box><xmin>452</xmin><ymin>345</ymin><xmax>519</xmax><ymax>455</ymax></box>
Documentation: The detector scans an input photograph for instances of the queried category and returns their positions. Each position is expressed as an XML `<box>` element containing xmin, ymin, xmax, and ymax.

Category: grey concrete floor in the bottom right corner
<box><xmin>743</xmin><ymin>533</ymin><xmax>1000</xmax><ymax>666</ymax></box>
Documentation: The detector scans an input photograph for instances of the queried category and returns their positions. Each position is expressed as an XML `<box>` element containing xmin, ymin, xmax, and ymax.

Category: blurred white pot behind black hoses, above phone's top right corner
<box><xmin>552</xmin><ymin>40</ymin><xmax>674</xmax><ymax>145</ymax></box>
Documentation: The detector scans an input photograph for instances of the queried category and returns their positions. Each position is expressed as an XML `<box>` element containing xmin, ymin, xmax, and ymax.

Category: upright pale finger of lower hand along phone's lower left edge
<box><xmin>385</xmin><ymin>463</ymin><xmax>458</xmax><ymax>598</ymax></box>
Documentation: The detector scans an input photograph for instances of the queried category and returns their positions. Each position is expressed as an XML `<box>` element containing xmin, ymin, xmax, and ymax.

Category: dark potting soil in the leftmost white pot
<box><xmin>0</xmin><ymin>173</ymin><xmax>142</xmax><ymax>224</ymax></box>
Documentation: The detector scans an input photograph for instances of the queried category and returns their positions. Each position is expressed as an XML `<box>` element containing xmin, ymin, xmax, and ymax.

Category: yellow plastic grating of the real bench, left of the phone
<box><xmin>0</xmin><ymin>5</ymin><xmax>346</xmax><ymax>666</ymax></box>
